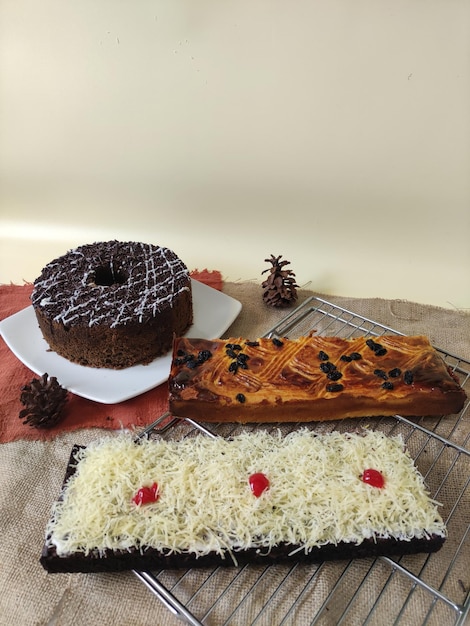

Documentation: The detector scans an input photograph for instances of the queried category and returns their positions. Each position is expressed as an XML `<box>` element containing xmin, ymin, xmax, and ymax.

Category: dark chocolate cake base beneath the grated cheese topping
<box><xmin>39</xmin><ymin>446</ymin><xmax>445</xmax><ymax>573</ymax></box>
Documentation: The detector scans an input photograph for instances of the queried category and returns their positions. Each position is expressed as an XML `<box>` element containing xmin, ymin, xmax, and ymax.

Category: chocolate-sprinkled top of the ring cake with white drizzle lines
<box><xmin>31</xmin><ymin>241</ymin><xmax>190</xmax><ymax>328</ymax></box>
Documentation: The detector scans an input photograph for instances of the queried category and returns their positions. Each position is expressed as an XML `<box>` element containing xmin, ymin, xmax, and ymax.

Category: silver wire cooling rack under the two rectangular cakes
<box><xmin>134</xmin><ymin>297</ymin><xmax>470</xmax><ymax>626</ymax></box>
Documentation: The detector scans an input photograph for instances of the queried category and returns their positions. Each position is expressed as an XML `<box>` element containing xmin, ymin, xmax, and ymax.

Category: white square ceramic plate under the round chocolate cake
<box><xmin>0</xmin><ymin>280</ymin><xmax>242</xmax><ymax>404</ymax></box>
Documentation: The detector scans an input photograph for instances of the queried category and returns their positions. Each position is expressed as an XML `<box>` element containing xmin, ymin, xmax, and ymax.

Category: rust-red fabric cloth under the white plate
<box><xmin>0</xmin><ymin>270</ymin><xmax>222</xmax><ymax>443</ymax></box>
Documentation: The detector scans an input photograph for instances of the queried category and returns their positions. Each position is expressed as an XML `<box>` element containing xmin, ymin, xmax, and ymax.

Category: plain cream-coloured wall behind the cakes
<box><xmin>0</xmin><ymin>0</ymin><xmax>470</xmax><ymax>309</ymax></box>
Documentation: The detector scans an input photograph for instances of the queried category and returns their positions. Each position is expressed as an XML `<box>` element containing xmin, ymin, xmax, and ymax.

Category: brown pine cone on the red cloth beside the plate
<box><xmin>19</xmin><ymin>373</ymin><xmax>67</xmax><ymax>428</ymax></box>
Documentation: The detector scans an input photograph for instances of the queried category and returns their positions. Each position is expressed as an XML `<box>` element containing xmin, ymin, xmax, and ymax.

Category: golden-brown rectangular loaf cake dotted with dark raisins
<box><xmin>169</xmin><ymin>335</ymin><xmax>466</xmax><ymax>423</ymax></box>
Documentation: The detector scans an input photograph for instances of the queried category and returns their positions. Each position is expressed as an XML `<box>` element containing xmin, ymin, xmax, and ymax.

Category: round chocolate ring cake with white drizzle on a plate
<box><xmin>31</xmin><ymin>241</ymin><xmax>193</xmax><ymax>369</ymax></box>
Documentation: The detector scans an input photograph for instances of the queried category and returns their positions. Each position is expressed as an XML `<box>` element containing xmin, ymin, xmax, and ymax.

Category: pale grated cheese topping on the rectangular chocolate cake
<box><xmin>46</xmin><ymin>429</ymin><xmax>446</xmax><ymax>558</ymax></box>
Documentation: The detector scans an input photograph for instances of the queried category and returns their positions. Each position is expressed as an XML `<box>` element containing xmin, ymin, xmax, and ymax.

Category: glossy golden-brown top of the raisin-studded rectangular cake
<box><xmin>170</xmin><ymin>335</ymin><xmax>464</xmax><ymax>415</ymax></box>
